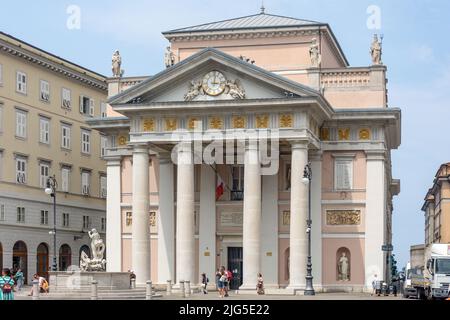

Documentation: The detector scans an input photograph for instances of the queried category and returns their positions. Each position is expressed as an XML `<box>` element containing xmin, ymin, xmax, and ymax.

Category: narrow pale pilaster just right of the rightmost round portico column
<box><xmin>310</xmin><ymin>151</ymin><xmax>322</xmax><ymax>290</ymax></box>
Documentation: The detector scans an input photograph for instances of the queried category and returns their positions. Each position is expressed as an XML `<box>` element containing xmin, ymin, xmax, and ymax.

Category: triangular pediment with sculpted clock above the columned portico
<box><xmin>109</xmin><ymin>48</ymin><xmax>320</xmax><ymax>106</ymax></box>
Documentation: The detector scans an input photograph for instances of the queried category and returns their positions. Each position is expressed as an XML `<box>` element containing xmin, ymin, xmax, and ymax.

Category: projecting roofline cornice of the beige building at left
<box><xmin>0</xmin><ymin>39</ymin><xmax>108</xmax><ymax>92</ymax></box>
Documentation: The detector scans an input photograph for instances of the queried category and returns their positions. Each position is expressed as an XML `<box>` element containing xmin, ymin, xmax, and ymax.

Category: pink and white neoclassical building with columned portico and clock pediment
<box><xmin>89</xmin><ymin>12</ymin><xmax>401</xmax><ymax>292</ymax></box>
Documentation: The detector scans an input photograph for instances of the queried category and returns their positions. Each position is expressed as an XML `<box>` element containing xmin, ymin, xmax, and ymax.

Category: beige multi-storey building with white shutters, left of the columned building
<box><xmin>0</xmin><ymin>32</ymin><xmax>107</xmax><ymax>281</ymax></box>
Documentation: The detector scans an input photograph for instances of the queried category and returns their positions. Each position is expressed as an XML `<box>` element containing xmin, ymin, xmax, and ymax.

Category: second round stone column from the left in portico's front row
<box><xmin>176</xmin><ymin>142</ymin><xmax>195</xmax><ymax>283</ymax></box>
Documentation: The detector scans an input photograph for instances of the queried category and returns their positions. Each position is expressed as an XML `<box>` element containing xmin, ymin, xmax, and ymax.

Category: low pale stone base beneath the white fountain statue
<box><xmin>48</xmin><ymin>271</ymin><xmax>130</xmax><ymax>292</ymax></box>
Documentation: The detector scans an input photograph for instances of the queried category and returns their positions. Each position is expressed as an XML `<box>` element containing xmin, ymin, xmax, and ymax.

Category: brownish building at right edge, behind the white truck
<box><xmin>422</xmin><ymin>162</ymin><xmax>450</xmax><ymax>246</ymax></box>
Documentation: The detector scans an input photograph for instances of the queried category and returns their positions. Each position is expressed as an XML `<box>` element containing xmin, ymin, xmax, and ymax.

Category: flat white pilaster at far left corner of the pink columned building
<box><xmin>106</xmin><ymin>157</ymin><xmax>122</xmax><ymax>272</ymax></box>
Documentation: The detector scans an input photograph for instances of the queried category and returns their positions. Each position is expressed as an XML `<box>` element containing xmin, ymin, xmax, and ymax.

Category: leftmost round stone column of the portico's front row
<box><xmin>131</xmin><ymin>145</ymin><xmax>151</xmax><ymax>286</ymax></box>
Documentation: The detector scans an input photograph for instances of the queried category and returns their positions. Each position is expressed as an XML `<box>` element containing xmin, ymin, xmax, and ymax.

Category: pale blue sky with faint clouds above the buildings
<box><xmin>0</xmin><ymin>0</ymin><xmax>450</xmax><ymax>269</ymax></box>
